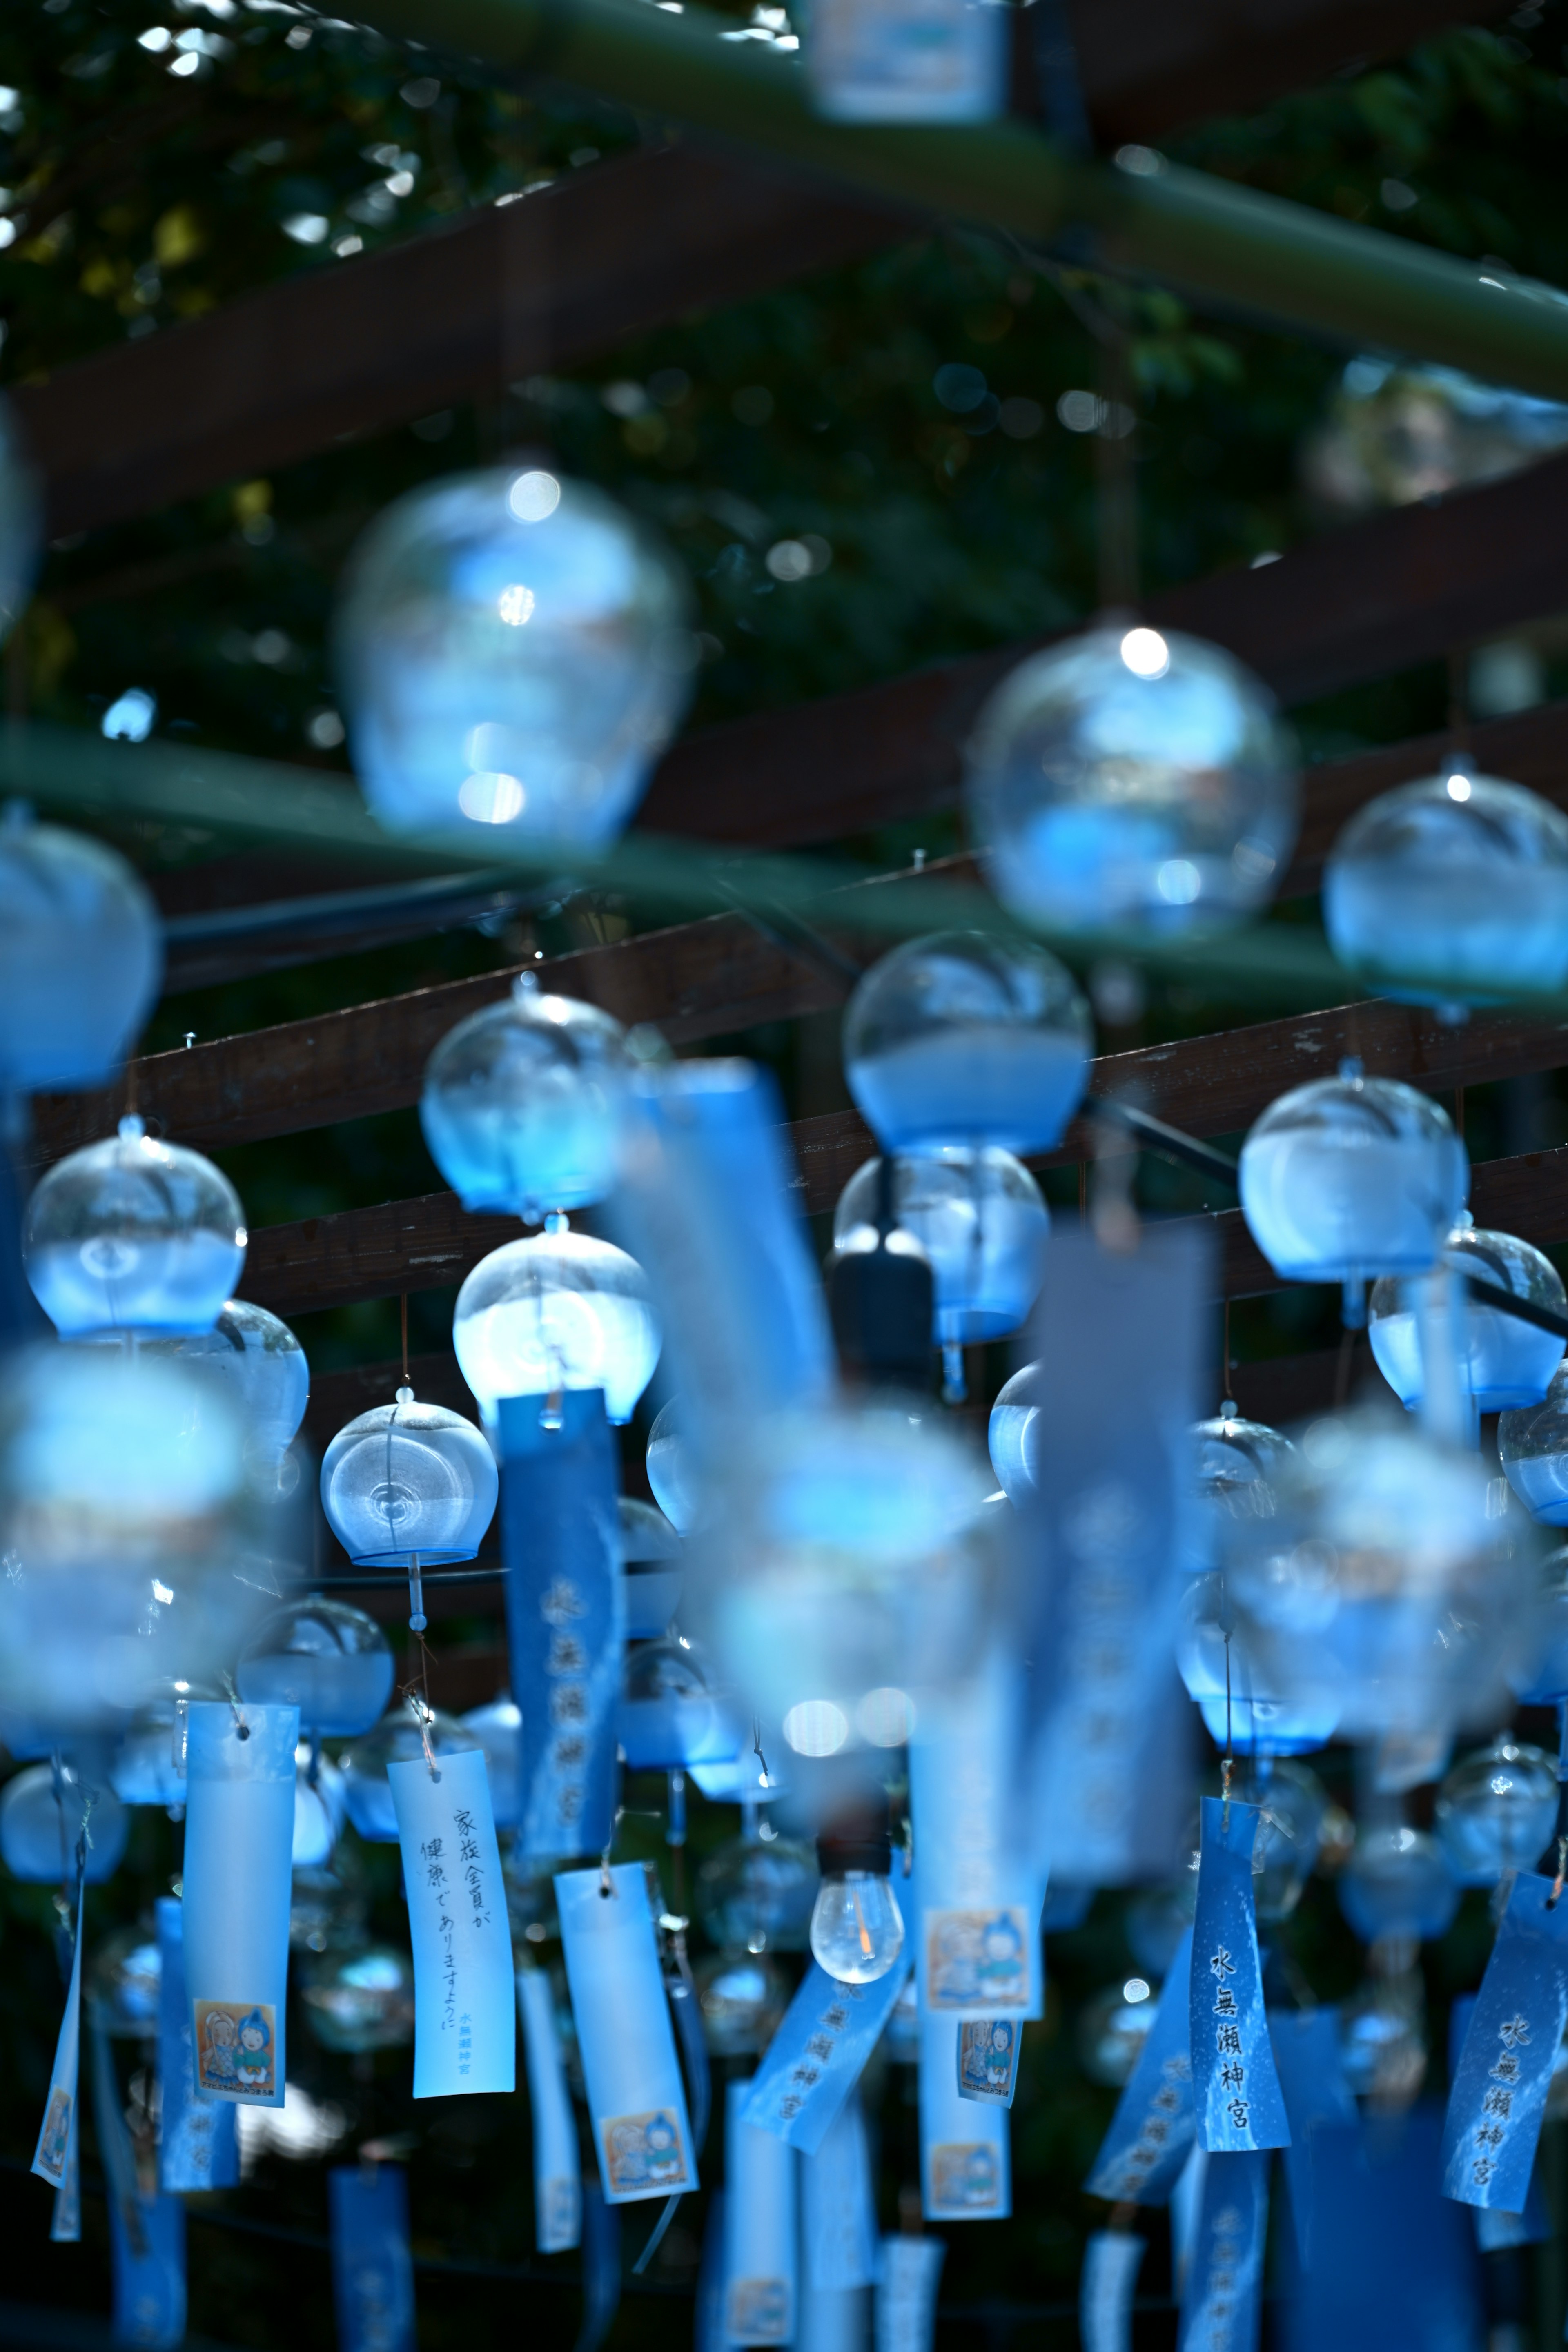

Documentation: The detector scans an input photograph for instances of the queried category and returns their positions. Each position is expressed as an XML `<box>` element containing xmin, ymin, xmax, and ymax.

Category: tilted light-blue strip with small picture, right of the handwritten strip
<box><xmin>555</xmin><ymin>1863</ymin><xmax>698</xmax><ymax>2204</ymax></box>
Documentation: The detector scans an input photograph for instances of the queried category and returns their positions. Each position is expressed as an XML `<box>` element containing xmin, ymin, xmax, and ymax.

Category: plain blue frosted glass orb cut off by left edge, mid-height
<box><xmin>0</xmin><ymin>813</ymin><xmax>162</xmax><ymax>1094</ymax></box>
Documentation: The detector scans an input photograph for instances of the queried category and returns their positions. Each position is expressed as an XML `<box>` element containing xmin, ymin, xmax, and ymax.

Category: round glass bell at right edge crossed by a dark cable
<box><xmin>1366</xmin><ymin>1221</ymin><xmax>1568</xmax><ymax>1414</ymax></box>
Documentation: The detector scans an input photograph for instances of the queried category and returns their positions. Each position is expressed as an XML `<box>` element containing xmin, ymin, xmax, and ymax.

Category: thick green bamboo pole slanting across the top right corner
<box><xmin>355</xmin><ymin>0</ymin><xmax>1568</xmax><ymax>400</ymax></box>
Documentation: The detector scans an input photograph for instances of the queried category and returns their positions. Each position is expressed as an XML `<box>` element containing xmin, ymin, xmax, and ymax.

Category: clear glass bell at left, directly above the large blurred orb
<box><xmin>21</xmin><ymin>1117</ymin><xmax>247</xmax><ymax>1338</ymax></box>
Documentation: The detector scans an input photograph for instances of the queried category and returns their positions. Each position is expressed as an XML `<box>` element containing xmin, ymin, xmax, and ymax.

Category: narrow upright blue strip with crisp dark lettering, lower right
<box><xmin>1187</xmin><ymin>1797</ymin><xmax>1291</xmax><ymax>2154</ymax></box>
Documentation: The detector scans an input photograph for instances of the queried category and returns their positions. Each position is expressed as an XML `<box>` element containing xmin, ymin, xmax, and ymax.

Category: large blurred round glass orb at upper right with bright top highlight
<box><xmin>966</xmin><ymin>626</ymin><xmax>1300</xmax><ymax>931</ymax></box>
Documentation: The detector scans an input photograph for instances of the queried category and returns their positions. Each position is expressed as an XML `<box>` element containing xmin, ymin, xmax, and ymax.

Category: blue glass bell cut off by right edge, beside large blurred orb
<box><xmin>1323</xmin><ymin>760</ymin><xmax>1568</xmax><ymax>1009</ymax></box>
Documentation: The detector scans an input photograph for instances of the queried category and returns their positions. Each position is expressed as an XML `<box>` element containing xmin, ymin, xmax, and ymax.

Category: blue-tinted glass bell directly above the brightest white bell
<box><xmin>419</xmin><ymin>971</ymin><xmax>630</xmax><ymax>1225</ymax></box>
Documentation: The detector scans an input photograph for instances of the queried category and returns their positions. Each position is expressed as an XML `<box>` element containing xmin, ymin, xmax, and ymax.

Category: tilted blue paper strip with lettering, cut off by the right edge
<box><xmin>1443</xmin><ymin>1870</ymin><xmax>1568</xmax><ymax>2213</ymax></box>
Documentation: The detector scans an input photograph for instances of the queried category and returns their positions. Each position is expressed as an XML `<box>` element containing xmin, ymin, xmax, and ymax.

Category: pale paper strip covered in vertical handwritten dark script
<box><xmin>385</xmin><ymin>1748</ymin><xmax>517</xmax><ymax>2098</ymax></box>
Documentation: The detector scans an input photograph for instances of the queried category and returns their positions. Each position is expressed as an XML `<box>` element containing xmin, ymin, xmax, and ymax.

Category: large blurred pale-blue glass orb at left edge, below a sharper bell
<box><xmin>0</xmin><ymin>1345</ymin><xmax>267</xmax><ymax>1733</ymax></box>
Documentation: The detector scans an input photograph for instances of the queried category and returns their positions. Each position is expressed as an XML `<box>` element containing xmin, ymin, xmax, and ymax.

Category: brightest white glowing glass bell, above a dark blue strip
<box><xmin>451</xmin><ymin>1216</ymin><xmax>661</xmax><ymax>1425</ymax></box>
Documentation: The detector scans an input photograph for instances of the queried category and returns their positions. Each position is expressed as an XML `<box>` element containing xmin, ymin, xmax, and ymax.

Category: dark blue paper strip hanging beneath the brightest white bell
<box><xmin>496</xmin><ymin>1388</ymin><xmax>625</xmax><ymax>1860</ymax></box>
